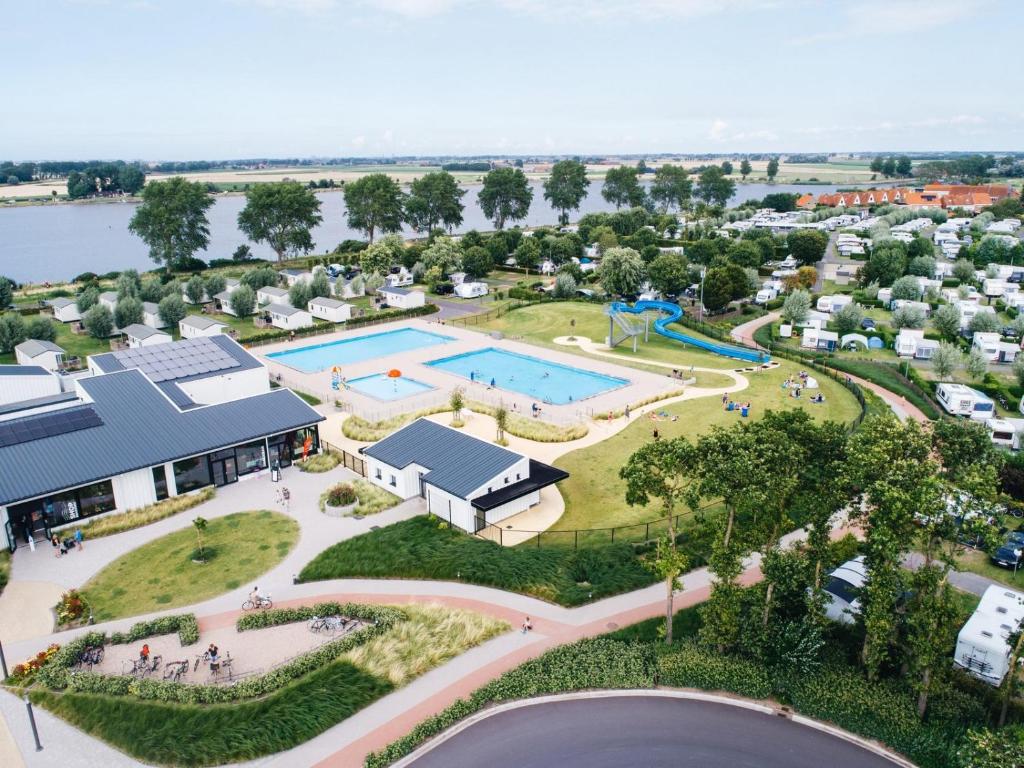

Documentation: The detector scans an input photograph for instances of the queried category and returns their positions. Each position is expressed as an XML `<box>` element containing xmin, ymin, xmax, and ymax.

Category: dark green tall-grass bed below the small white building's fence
<box><xmin>299</xmin><ymin>517</ymin><xmax>654</xmax><ymax>605</ymax></box>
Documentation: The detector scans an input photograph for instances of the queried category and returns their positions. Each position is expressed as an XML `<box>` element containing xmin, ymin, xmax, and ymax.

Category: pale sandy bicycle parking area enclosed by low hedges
<box><xmin>93</xmin><ymin>622</ymin><xmax>368</xmax><ymax>684</ymax></box>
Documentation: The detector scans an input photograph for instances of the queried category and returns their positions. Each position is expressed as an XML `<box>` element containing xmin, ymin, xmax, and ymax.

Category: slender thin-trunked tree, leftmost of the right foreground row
<box><xmin>618</xmin><ymin>437</ymin><xmax>699</xmax><ymax>643</ymax></box>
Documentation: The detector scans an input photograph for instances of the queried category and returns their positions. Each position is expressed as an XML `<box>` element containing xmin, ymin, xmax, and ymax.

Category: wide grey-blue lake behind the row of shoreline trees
<box><xmin>0</xmin><ymin>181</ymin><xmax>838</xmax><ymax>283</ymax></box>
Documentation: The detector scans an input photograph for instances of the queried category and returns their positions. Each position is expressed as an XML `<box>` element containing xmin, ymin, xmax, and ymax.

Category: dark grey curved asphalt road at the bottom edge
<box><xmin>405</xmin><ymin>696</ymin><xmax>894</xmax><ymax>768</ymax></box>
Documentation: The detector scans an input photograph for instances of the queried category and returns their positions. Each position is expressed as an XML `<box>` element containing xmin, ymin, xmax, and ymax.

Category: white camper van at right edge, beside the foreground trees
<box><xmin>953</xmin><ymin>585</ymin><xmax>1024</xmax><ymax>686</ymax></box>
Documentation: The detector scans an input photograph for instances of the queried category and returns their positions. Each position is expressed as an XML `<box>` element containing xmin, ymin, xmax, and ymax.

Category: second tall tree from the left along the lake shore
<box><xmin>239</xmin><ymin>181</ymin><xmax>324</xmax><ymax>261</ymax></box>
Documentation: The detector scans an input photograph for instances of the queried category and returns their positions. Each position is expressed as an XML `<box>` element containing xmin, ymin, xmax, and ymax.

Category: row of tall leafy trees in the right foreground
<box><xmin>621</xmin><ymin>411</ymin><xmax>1010</xmax><ymax>717</ymax></box>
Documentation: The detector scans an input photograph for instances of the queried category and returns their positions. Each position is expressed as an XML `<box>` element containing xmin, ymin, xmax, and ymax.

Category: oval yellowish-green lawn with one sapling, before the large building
<box><xmin>82</xmin><ymin>510</ymin><xmax>299</xmax><ymax>622</ymax></box>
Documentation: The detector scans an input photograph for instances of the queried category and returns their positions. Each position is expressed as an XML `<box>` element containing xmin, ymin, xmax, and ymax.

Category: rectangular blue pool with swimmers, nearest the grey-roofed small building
<box><xmin>426</xmin><ymin>347</ymin><xmax>630</xmax><ymax>406</ymax></box>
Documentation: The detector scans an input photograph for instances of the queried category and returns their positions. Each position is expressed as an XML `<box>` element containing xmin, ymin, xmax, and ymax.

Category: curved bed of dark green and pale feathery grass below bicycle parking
<box><xmin>32</xmin><ymin>605</ymin><xmax>508</xmax><ymax>766</ymax></box>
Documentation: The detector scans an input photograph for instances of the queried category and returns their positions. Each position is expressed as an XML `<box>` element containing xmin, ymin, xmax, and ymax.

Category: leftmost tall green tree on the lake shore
<box><xmin>128</xmin><ymin>176</ymin><xmax>213</xmax><ymax>271</ymax></box>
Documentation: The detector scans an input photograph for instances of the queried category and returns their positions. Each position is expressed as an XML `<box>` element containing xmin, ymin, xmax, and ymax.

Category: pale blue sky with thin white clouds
<box><xmin>0</xmin><ymin>0</ymin><xmax>1024</xmax><ymax>161</ymax></box>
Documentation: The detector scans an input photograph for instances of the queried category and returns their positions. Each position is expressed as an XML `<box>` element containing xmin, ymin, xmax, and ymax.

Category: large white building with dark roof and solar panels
<box><xmin>0</xmin><ymin>336</ymin><xmax>324</xmax><ymax>549</ymax></box>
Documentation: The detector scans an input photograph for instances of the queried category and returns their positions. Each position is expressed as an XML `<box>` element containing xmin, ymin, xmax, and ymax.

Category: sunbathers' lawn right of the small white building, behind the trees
<box><xmin>554</xmin><ymin>360</ymin><xmax>860</xmax><ymax>529</ymax></box>
